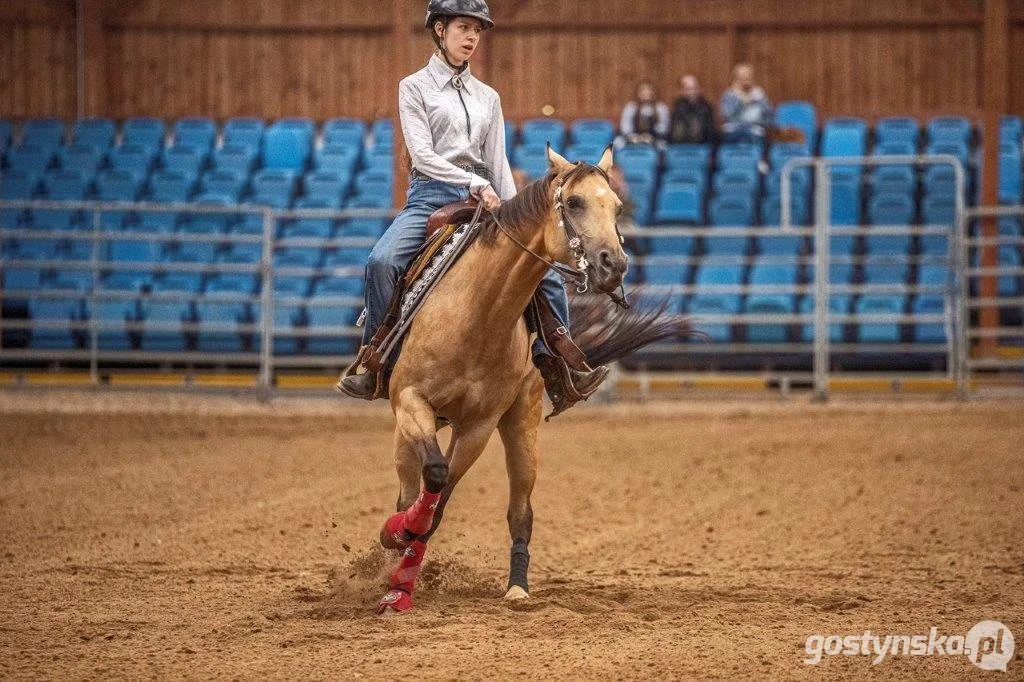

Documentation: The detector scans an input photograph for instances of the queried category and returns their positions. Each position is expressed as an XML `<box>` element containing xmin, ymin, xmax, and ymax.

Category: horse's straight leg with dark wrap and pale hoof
<box><xmin>498</xmin><ymin>371</ymin><xmax>544</xmax><ymax>599</ymax></box>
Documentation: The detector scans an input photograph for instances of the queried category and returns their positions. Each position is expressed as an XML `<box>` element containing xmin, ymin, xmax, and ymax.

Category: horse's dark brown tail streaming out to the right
<box><xmin>569</xmin><ymin>290</ymin><xmax>701</xmax><ymax>367</ymax></box>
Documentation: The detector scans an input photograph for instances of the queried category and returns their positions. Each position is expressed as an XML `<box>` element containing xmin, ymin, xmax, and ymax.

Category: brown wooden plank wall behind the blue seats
<box><xmin>0</xmin><ymin>0</ymin><xmax>1024</xmax><ymax>120</ymax></box>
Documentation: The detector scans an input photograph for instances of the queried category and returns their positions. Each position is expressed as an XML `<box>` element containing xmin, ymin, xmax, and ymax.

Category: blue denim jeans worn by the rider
<box><xmin>362</xmin><ymin>173</ymin><xmax>569</xmax><ymax>356</ymax></box>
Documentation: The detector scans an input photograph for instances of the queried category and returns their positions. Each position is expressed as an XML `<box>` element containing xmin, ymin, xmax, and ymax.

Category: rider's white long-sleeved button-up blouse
<box><xmin>398</xmin><ymin>54</ymin><xmax>515</xmax><ymax>201</ymax></box>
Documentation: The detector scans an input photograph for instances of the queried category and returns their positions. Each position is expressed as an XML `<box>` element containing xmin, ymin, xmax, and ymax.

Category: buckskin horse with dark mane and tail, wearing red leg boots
<box><xmin>368</xmin><ymin>147</ymin><xmax>687</xmax><ymax>614</ymax></box>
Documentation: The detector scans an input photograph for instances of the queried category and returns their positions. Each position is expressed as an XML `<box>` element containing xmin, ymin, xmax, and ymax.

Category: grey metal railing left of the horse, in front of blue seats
<box><xmin>0</xmin><ymin>196</ymin><xmax>394</xmax><ymax>390</ymax></box>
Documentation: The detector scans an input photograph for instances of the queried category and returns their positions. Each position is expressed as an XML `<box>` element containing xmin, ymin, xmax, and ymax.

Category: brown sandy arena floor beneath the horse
<box><xmin>0</xmin><ymin>392</ymin><xmax>1024</xmax><ymax>680</ymax></box>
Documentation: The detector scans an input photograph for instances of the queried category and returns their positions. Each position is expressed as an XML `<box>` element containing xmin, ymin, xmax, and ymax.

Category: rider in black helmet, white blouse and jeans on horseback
<box><xmin>339</xmin><ymin>0</ymin><xmax>608</xmax><ymax>410</ymax></box>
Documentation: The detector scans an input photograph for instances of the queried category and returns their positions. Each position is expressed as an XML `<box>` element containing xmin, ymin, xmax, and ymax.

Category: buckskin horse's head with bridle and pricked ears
<box><xmin>544</xmin><ymin>146</ymin><xmax>627</xmax><ymax>293</ymax></box>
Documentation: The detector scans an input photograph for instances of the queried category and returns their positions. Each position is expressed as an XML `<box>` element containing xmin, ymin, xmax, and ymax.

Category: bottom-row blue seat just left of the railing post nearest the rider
<box><xmin>196</xmin><ymin>275</ymin><xmax>252</xmax><ymax>353</ymax></box>
